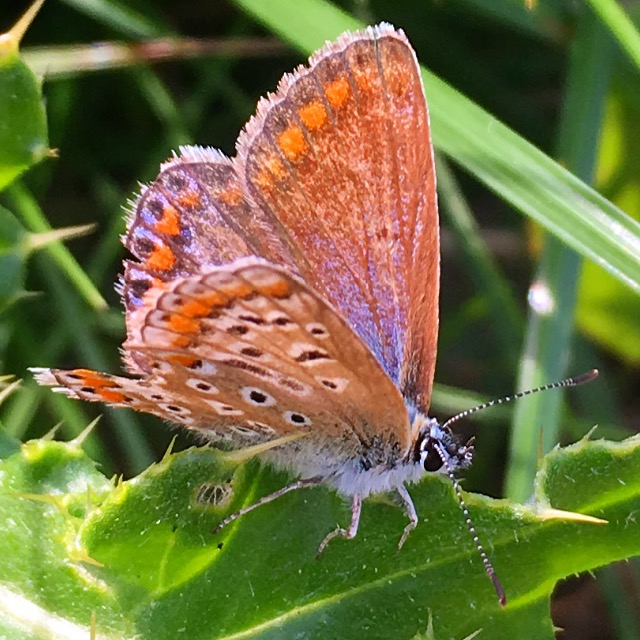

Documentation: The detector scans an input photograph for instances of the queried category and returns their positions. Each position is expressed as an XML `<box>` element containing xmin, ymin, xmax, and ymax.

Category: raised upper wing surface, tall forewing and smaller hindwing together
<box><xmin>118</xmin><ymin>25</ymin><xmax>439</xmax><ymax>412</ymax></box>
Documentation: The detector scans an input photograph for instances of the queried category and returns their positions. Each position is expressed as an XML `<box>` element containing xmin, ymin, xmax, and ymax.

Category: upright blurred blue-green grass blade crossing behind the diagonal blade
<box><xmin>506</xmin><ymin>8</ymin><xmax>613</xmax><ymax>501</ymax></box>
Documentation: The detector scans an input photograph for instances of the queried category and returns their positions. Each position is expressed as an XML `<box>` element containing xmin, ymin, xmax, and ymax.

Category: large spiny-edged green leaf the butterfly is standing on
<box><xmin>0</xmin><ymin>437</ymin><xmax>640</xmax><ymax>640</ymax></box>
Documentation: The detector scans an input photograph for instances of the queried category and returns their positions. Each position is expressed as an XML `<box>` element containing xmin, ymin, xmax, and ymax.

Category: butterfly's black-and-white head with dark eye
<box><xmin>413</xmin><ymin>415</ymin><xmax>473</xmax><ymax>474</ymax></box>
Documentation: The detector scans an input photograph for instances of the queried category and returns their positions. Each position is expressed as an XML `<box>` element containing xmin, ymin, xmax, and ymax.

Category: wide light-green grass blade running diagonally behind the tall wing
<box><xmin>235</xmin><ymin>0</ymin><xmax>640</xmax><ymax>292</ymax></box>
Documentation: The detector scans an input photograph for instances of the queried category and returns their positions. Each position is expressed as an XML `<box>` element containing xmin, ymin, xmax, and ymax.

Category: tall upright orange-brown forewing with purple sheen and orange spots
<box><xmin>236</xmin><ymin>25</ymin><xmax>439</xmax><ymax>412</ymax></box>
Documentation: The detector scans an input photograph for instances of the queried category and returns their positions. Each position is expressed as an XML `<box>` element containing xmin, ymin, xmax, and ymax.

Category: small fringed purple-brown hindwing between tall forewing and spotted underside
<box><xmin>120</xmin><ymin>147</ymin><xmax>295</xmax><ymax>372</ymax></box>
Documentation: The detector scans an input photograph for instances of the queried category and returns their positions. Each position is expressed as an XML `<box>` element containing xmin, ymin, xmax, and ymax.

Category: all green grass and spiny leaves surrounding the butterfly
<box><xmin>0</xmin><ymin>0</ymin><xmax>640</xmax><ymax>640</ymax></box>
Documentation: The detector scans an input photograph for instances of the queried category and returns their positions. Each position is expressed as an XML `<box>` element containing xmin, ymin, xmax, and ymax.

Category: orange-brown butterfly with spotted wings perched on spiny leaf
<box><xmin>36</xmin><ymin>23</ymin><xmax>504</xmax><ymax>602</ymax></box>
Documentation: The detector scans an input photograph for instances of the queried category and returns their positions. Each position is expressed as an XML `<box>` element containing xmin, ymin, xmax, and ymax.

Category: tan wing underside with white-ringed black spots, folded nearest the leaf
<box><xmin>37</xmin><ymin>259</ymin><xmax>410</xmax><ymax>458</ymax></box>
